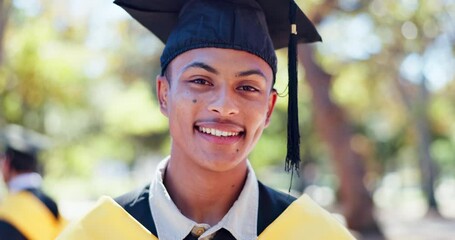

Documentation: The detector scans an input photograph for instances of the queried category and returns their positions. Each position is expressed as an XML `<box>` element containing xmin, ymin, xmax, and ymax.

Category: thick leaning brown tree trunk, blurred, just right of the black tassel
<box><xmin>299</xmin><ymin>45</ymin><xmax>382</xmax><ymax>238</ymax></box>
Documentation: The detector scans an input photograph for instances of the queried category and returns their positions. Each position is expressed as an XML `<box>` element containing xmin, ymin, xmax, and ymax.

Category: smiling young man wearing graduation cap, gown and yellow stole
<box><xmin>60</xmin><ymin>0</ymin><xmax>353</xmax><ymax>240</ymax></box>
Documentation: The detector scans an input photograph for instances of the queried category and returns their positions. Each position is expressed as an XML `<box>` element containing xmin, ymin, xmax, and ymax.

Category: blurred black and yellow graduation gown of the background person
<box><xmin>0</xmin><ymin>189</ymin><xmax>65</xmax><ymax>240</ymax></box>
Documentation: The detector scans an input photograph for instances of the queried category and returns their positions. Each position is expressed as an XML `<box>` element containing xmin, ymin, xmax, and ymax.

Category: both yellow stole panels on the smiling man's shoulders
<box><xmin>57</xmin><ymin>195</ymin><xmax>355</xmax><ymax>240</ymax></box>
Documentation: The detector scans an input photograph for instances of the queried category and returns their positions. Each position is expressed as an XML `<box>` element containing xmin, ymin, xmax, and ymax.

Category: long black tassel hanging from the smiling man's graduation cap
<box><xmin>285</xmin><ymin>0</ymin><xmax>300</xmax><ymax>174</ymax></box>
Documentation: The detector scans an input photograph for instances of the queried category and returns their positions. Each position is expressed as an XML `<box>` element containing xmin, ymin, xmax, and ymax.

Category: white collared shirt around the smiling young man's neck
<box><xmin>149</xmin><ymin>158</ymin><xmax>259</xmax><ymax>240</ymax></box>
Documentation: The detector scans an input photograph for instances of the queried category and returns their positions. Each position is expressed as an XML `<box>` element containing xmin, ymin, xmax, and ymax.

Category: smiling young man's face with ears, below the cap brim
<box><xmin>157</xmin><ymin>48</ymin><xmax>276</xmax><ymax>171</ymax></box>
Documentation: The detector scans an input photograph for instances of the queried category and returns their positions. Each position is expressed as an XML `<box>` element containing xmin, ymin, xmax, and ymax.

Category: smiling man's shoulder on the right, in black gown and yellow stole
<box><xmin>257</xmin><ymin>182</ymin><xmax>355</xmax><ymax>240</ymax></box>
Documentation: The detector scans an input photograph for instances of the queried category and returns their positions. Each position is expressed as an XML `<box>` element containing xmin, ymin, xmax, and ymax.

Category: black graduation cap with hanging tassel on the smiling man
<box><xmin>114</xmin><ymin>0</ymin><xmax>321</xmax><ymax>171</ymax></box>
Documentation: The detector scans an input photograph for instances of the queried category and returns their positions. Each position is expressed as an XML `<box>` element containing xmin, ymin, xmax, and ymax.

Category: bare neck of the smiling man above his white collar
<box><xmin>163</xmin><ymin>157</ymin><xmax>248</xmax><ymax>226</ymax></box>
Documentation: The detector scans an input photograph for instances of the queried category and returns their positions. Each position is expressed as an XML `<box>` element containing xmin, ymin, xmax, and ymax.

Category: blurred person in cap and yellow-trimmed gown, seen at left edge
<box><xmin>0</xmin><ymin>126</ymin><xmax>65</xmax><ymax>240</ymax></box>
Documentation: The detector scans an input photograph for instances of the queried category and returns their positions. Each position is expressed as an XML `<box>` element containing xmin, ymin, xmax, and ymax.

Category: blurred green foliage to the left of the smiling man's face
<box><xmin>0</xmin><ymin>1</ymin><xmax>167</xmax><ymax>182</ymax></box>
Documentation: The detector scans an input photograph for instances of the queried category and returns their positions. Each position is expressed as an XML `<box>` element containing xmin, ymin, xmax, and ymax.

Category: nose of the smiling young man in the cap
<box><xmin>208</xmin><ymin>90</ymin><xmax>239</xmax><ymax>116</ymax></box>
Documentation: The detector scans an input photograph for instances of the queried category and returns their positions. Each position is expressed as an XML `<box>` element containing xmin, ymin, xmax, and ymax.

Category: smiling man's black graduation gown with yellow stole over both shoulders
<box><xmin>57</xmin><ymin>182</ymin><xmax>354</xmax><ymax>240</ymax></box>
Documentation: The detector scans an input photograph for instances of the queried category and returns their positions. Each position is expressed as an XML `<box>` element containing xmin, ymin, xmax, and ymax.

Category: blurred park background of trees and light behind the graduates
<box><xmin>0</xmin><ymin>0</ymin><xmax>455</xmax><ymax>240</ymax></box>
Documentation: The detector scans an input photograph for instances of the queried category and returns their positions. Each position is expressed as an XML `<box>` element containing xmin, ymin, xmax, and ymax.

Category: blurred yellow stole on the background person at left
<box><xmin>0</xmin><ymin>191</ymin><xmax>65</xmax><ymax>240</ymax></box>
